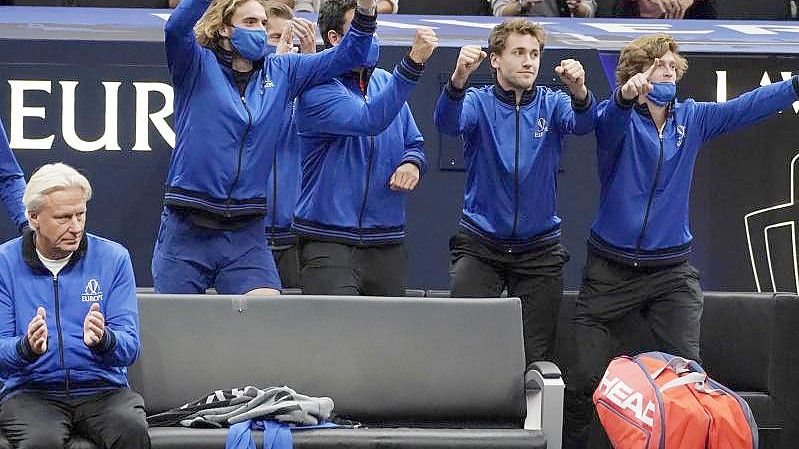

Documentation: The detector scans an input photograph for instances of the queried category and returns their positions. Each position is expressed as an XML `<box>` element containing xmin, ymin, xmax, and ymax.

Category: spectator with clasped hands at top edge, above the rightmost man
<box><xmin>613</xmin><ymin>0</ymin><xmax>716</xmax><ymax>19</ymax></box>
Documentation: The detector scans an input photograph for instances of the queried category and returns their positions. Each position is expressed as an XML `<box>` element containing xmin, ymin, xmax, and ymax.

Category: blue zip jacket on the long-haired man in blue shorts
<box><xmin>164</xmin><ymin>0</ymin><xmax>376</xmax><ymax>217</ymax></box>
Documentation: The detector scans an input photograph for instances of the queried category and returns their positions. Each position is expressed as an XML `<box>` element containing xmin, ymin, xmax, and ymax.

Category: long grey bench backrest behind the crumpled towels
<box><xmin>130</xmin><ymin>294</ymin><xmax>525</xmax><ymax>423</ymax></box>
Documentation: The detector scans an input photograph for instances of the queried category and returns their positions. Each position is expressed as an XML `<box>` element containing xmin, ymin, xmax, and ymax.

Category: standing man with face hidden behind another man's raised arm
<box><xmin>293</xmin><ymin>0</ymin><xmax>438</xmax><ymax>296</ymax></box>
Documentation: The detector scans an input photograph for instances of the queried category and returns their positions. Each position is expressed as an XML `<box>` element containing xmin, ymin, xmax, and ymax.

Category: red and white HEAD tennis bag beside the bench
<box><xmin>594</xmin><ymin>352</ymin><xmax>758</xmax><ymax>449</ymax></box>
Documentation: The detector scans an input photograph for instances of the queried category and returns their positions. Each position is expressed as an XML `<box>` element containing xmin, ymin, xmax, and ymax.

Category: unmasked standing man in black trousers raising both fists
<box><xmin>435</xmin><ymin>19</ymin><xmax>596</xmax><ymax>364</ymax></box>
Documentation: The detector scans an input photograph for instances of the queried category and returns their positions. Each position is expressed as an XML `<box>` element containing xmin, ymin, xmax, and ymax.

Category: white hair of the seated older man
<box><xmin>22</xmin><ymin>162</ymin><xmax>92</xmax><ymax>218</ymax></box>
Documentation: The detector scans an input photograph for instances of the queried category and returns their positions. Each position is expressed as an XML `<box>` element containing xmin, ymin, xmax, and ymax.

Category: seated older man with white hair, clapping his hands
<box><xmin>0</xmin><ymin>163</ymin><xmax>150</xmax><ymax>449</ymax></box>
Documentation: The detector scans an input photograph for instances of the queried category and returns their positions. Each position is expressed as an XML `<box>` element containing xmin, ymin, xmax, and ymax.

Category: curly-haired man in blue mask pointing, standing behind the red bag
<box><xmin>564</xmin><ymin>34</ymin><xmax>799</xmax><ymax>448</ymax></box>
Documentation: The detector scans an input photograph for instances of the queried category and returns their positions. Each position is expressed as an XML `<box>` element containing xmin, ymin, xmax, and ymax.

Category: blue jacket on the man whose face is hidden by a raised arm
<box><xmin>294</xmin><ymin>56</ymin><xmax>426</xmax><ymax>246</ymax></box>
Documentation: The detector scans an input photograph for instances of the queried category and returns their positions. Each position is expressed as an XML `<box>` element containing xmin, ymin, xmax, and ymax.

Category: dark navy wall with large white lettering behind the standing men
<box><xmin>0</xmin><ymin>33</ymin><xmax>799</xmax><ymax>290</ymax></box>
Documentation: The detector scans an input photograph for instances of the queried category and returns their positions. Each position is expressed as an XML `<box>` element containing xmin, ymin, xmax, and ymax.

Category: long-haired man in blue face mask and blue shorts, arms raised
<box><xmin>152</xmin><ymin>0</ymin><xmax>376</xmax><ymax>295</ymax></box>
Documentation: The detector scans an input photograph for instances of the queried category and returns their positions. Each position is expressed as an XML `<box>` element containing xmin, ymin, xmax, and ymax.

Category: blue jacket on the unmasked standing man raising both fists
<box><xmin>434</xmin><ymin>83</ymin><xmax>596</xmax><ymax>252</ymax></box>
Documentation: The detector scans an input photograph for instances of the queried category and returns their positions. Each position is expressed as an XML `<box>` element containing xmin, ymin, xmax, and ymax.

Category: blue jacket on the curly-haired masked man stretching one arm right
<box><xmin>588</xmin><ymin>77</ymin><xmax>799</xmax><ymax>266</ymax></box>
